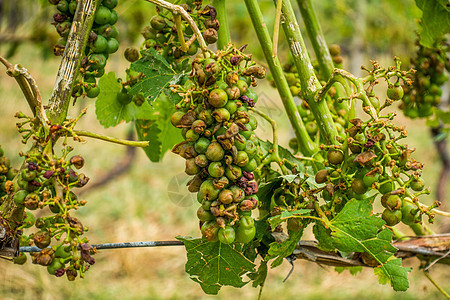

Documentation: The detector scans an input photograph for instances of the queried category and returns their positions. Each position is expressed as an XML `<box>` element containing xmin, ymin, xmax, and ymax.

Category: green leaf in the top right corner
<box><xmin>416</xmin><ymin>0</ymin><xmax>450</xmax><ymax>48</ymax></box>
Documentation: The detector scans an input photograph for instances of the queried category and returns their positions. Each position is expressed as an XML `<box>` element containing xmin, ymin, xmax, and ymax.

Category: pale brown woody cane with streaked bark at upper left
<box><xmin>47</xmin><ymin>0</ymin><xmax>100</xmax><ymax>124</ymax></box>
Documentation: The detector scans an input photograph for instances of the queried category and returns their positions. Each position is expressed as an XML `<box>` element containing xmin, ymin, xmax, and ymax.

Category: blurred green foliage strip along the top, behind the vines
<box><xmin>0</xmin><ymin>0</ymin><xmax>421</xmax><ymax>69</ymax></box>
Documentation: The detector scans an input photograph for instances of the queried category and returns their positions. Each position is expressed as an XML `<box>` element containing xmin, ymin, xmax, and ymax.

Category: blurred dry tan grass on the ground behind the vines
<box><xmin>0</xmin><ymin>42</ymin><xmax>450</xmax><ymax>300</ymax></box>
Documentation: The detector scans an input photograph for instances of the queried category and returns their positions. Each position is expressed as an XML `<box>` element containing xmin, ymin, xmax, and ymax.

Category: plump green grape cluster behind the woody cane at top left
<box><xmin>50</xmin><ymin>0</ymin><xmax>119</xmax><ymax>98</ymax></box>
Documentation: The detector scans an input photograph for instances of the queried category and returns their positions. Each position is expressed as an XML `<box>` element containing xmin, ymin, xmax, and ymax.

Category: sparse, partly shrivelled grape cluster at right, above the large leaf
<box><xmin>268</xmin><ymin>60</ymin><xmax>439</xmax><ymax>234</ymax></box>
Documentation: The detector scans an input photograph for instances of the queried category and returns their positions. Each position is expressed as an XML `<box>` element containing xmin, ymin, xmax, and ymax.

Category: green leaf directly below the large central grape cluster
<box><xmin>177</xmin><ymin>236</ymin><xmax>255</xmax><ymax>294</ymax></box>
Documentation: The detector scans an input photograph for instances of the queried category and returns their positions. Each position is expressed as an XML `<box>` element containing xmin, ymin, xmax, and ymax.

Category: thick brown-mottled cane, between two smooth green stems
<box><xmin>274</xmin><ymin>0</ymin><xmax>339</xmax><ymax>145</ymax></box>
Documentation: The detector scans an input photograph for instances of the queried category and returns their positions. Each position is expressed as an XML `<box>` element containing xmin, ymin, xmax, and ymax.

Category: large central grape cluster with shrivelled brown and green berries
<box><xmin>171</xmin><ymin>48</ymin><xmax>266</xmax><ymax>244</ymax></box>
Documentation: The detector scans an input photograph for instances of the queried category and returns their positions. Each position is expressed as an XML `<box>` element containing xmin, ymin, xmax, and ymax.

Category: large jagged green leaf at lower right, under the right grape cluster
<box><xmin>320</xmin><ymin>199</ymin><xmax>408</xmax><ymax>291</ymax></box>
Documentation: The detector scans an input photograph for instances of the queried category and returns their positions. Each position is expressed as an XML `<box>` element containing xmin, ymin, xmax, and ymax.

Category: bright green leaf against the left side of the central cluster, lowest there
<box><xmin>136</xmin><ymin>96</ymin><xmax>182</xmax><ymax>162</ymax></box>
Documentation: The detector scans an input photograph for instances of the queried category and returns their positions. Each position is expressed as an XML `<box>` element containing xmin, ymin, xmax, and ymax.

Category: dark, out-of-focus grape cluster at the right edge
<box><xmin>400</xmin><ymin>41</ymin><xmax>450</xmax><ymax>118</ymax></box>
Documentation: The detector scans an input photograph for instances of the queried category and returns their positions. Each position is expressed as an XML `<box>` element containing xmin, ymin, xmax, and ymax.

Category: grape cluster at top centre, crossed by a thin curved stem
<box><xmin>142</xmin><ymin>1</ymin><xmax>220</xmax><ymax>63</ymax></box>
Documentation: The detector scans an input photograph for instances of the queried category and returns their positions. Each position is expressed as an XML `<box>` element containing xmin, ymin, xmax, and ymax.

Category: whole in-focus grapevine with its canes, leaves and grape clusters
<box><xmin>0</xmin><ymin>0</ymin><xmax>450</xmax><ymax>294</ymax></box>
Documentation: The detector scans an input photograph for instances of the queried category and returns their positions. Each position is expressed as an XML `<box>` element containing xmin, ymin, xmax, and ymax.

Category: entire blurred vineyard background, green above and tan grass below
<box><xmin>0</xmin><ymin>0</ymin><xmax>450</xmax><ymax>300</ymax></box>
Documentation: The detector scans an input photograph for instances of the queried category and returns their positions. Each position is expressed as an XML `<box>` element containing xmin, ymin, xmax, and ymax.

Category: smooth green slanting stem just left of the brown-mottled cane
<box><xmin>245</xmin><ymin>0</ymin><xmax>318</xmax><ymax>156</ymax></box>
